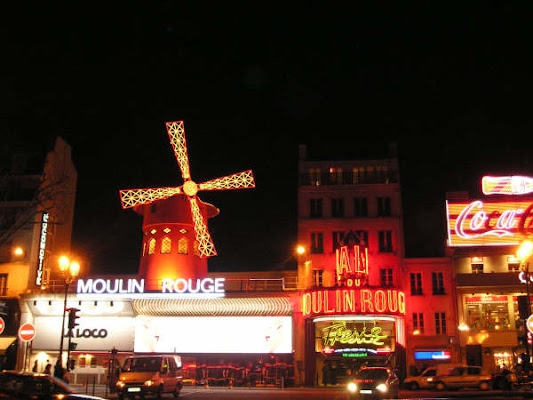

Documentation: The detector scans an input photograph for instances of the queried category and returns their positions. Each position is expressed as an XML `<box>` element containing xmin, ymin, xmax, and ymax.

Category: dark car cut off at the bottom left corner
<box><xmin>0</xmin><ymin>371</ymin><xmax>104</xmax><ymax>400</ymax></box>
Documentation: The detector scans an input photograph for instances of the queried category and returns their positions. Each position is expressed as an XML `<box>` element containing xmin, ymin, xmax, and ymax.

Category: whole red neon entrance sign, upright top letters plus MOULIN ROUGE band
<box><xmin>302</xmin><ymin>246</ymin><xmax>405</xmax><ymax>316</ymax></box>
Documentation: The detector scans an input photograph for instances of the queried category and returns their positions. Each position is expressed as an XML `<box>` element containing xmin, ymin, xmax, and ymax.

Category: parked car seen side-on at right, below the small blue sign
<box><xmin>429</xmin><ymin>366</ymin><xmax>492</xmax><ymax>390</ymax></box>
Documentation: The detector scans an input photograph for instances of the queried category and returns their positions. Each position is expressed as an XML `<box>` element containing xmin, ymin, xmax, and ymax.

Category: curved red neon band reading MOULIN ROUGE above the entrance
<box><xmin>302</xmin><ymin>289</ymin><xmax>405</xmax><ymax>316</ymax></box>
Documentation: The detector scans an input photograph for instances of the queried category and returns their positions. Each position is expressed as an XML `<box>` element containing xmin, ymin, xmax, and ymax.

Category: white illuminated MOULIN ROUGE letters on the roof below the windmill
<box><xmin>76</xmin><ymin>278</ymin><xmax>225</xmax><ymax>294</ymax></box>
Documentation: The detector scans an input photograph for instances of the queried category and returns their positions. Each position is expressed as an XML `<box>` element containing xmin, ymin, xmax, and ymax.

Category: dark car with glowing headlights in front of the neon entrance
<box><xmin>347</xmin><ymin>367</ymin><xmax>400</xmax><ymax>399</ymax></box>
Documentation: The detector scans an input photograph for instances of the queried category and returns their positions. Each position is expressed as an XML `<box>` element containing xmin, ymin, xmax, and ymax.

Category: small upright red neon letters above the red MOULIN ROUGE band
<box><xmin>335</xmin><ymin>245</ymin><xmax>368</xmax><ymax>287</ymax></box>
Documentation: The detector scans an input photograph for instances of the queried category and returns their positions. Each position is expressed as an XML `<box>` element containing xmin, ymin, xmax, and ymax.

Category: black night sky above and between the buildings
<box><xmin>0</xmin><ymin>1</ymin><xmax>533</xmax><ymax>274</ymax></box>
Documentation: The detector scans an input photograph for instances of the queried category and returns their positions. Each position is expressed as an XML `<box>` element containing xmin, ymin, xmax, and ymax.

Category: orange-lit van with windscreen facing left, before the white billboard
<box><xmin>116</xmin><ymin>354</ymin><xmax>183</xmax><ymax>399</ymax></box>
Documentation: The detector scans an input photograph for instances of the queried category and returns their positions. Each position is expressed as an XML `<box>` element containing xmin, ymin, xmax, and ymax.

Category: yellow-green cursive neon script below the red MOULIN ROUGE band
<box><xmin>322</xmin><ymin>321</ymin><xmax>388</xmax><ymax>346</ymax></box>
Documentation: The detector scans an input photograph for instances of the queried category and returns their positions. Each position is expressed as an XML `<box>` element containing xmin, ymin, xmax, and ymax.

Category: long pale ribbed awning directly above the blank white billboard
<box><xmin>133</xmin><ymin>297</ymin><xmax>292</xmax><ymax>316</ymax></box>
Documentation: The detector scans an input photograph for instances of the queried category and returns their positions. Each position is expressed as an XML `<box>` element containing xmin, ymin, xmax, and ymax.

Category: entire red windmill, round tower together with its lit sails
<box><xmin>120</xmin><ymin>121</ymin><xmax>255</xmax><ymax>290</ymax></box>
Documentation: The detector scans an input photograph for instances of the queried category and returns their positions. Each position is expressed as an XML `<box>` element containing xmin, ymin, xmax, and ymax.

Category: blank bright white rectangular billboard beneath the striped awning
<box><xmin>135</xmin><ymin>316</ymin><xmax>293</xmax><ymax>354</ymax></box>
